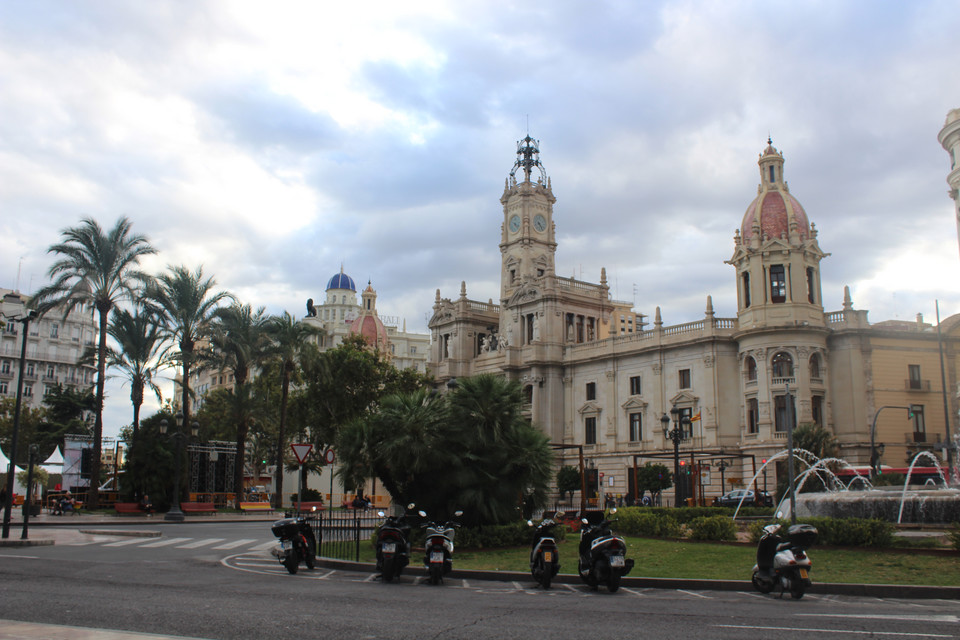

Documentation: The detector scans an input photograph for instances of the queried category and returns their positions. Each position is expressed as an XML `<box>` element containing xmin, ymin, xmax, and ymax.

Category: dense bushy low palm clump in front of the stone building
<box><xmin>338</xmin><ymin>375</ymin><xmax>554</xmax><ymax>524</ymax></box>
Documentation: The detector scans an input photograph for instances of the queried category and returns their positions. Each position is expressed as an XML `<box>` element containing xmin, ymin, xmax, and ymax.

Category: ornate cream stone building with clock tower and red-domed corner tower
<box><xmin>429</xmin><ymin>136</ymin><xmax>960</xmax><ymax>501</ymax></box>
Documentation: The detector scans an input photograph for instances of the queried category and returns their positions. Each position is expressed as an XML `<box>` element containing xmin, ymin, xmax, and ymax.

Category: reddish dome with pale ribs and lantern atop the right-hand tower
<box><xmin>740</xmin><ymin>139</ymin><xmax>810</xmax><ymax>241</ymax></box>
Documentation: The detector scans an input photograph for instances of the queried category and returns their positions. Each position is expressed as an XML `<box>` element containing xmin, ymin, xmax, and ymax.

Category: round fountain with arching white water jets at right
<box><xmin>733</xmin><ymin>449</ymin><xmax>960</xmax><ymax>524</ymax></box>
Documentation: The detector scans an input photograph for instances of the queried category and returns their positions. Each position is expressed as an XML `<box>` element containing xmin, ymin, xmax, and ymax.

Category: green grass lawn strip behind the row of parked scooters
<box><xmin>332</xmin><ymin>535</ymin><xmax>960</xmax><ymax>586</ymax></box>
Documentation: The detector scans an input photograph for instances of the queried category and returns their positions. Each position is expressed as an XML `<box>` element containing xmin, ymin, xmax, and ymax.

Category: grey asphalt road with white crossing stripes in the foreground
<box><xmin>0</xmin><ymin>522</ymin><xmax>960</xmax><ymax>640</ymax></box>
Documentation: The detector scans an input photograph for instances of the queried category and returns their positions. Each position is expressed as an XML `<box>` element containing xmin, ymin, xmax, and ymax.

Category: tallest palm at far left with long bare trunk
<box><xmin>33</xmin><ymin>217</ymin><xmax>156</xmax><ymax>509</ymax></box>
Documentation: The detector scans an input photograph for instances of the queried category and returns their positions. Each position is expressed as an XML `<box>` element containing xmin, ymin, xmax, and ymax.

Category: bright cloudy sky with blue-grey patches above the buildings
<box><xmin>0</xmin><ymin>0</ymin><xmax>960</xmax><ymax>434</ymax></box>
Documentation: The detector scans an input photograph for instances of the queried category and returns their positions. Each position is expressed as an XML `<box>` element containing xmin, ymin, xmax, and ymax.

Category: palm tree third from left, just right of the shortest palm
<box><xmin>146</xmin><ymin>265</ymin><xmax>233</xmax><ymax>440</ymax></box>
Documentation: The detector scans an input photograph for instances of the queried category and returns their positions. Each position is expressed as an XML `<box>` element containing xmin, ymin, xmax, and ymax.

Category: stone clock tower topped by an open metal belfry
<box><xmin>500</xmin><ymin>135</ymin><xmax>557</xmax><ymax>301</ymax></box>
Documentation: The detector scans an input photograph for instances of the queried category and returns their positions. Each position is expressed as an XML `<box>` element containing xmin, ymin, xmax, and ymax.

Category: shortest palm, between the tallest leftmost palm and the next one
<box><xmin>107</xmin><ymin>308</ymin><xmax>163</xmax><ymax>440</ymax></box>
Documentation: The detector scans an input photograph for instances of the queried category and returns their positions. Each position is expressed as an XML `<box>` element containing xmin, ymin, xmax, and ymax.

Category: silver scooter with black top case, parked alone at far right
<box><xmin>753</xmin><ymin>524</ymin><xmax>817</xmax><ymax>600</ymax></box>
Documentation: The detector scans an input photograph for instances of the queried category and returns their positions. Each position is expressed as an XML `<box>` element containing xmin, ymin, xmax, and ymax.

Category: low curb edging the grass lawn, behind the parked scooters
<box><xmin>317</xmin><ymin>558</ymin><xmax>960</xmax><ymax>600</ymax></box>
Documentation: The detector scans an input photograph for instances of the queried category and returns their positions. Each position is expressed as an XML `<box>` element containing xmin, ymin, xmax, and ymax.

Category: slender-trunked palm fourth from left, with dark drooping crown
<box><xmin>205</xmin><ymin>302</ymin><xmax>269</xmax><ymax>509</ymax></box>
